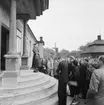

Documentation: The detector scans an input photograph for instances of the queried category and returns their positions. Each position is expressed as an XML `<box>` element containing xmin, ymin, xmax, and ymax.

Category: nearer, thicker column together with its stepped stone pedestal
<box><xmin>2</xmin><ymin>0</ymin><xmax>20</xmax><ymax>88</ymax></box>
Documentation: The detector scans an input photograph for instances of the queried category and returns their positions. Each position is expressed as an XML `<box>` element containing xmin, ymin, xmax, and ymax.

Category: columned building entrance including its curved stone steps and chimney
<box><xmin>0</xmin><ymin>0</ymin><xmax>58</xmax><ymax>105</ymax></box>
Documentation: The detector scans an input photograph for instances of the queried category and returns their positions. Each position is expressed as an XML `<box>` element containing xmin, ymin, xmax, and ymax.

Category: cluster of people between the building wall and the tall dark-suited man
<box><xmin>31</xmin><ymin>49</ymin><xmax>59</xmax><ymax>78</ymax></box>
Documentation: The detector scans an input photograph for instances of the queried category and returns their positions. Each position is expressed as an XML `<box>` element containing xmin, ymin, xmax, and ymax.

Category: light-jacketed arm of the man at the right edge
<box><xmin>87</xmin><ymin>70</ymin><xmax>100</xmax><ymax>99</ymax></box>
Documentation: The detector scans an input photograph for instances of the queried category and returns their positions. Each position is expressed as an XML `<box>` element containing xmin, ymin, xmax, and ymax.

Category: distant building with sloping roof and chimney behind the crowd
<box><xmin>81</xmin><ymin>35</ymin><xmax>104</xmax><ymax>57</ymax></box>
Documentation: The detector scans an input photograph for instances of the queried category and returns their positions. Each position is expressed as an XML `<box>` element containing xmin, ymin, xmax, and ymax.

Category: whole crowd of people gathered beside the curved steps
<box><xmin>32</xmin><ymin>49</ymin><xmax>104</xmax><ymax>105</ymax></box>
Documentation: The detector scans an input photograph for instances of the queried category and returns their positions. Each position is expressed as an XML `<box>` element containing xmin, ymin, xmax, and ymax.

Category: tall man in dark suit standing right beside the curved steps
<box><xmin>57</xmin><ymin>61</ymin><xmax>69</xmax><ymax>105</ymax></box>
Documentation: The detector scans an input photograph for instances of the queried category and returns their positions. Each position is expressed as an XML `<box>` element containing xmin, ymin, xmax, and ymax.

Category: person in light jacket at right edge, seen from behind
<box><xmin>86</xmin><ymin>56</ymin><xmax>104</xmax><ymax>105</ymax></box>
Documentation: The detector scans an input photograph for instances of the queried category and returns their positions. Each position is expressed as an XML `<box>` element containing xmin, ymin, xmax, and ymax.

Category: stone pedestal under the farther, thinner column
<box><xmin>20</xmin><ymin>56</ymin><xmax>29</xmax><ymax>70</ymax></box>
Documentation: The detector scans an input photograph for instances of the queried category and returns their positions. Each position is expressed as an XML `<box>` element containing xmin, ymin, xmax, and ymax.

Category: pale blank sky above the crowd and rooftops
<box><xmin>28</xmin><ymin>0</ymin><xmax>104</xmax><ymax>51</ymax></box>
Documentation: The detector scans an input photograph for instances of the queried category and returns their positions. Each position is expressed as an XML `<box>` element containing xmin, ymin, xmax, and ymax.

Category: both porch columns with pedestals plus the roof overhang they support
<box><xmin>2</xmin><ymin>0</ymin><xmax>48</xmax><ymax>87</ymax></box>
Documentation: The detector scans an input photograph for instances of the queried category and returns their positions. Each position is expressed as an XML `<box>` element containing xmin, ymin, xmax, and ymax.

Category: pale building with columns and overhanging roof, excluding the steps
<box><xmin>0</xmin><ymin>0</ymin><xmax>49</xmax><ymax>70</ymax></box>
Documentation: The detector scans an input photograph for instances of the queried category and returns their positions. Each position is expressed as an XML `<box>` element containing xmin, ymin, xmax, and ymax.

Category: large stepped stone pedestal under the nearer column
<box><xmin>1</xmin><ymin>54</ymin><xmax>20</xmax><ymax>88</ymax></box>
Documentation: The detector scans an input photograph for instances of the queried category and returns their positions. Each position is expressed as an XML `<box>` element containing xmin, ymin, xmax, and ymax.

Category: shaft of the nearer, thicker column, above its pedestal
<box><xmin>9</xmin><ymin>0</ymin><xmax>17</xmax><ymax>54</ymax></box>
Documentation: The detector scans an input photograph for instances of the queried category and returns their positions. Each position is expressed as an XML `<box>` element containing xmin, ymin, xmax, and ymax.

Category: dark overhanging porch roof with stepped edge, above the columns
<box><xmin>0</xmin><ymin>0</ymin><xmax>49</xmax><ymax>19</ymax></box>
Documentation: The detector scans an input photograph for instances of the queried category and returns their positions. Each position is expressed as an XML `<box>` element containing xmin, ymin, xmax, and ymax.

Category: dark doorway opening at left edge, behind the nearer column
<box><xmin>1</xmin><ymin>26</ymin><xmax>9</xmax><ymax>71</ymax></box>
